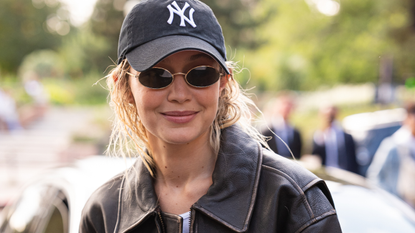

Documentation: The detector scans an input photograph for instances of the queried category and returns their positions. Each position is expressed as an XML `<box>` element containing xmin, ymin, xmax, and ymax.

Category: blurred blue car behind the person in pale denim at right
<box><xmin>342</xmin><ymin>108</ymin><xmax>406</xmax><ymax>176</ymax></box>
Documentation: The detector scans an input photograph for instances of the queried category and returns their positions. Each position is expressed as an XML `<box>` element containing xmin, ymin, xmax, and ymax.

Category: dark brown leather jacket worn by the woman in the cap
<box><xmin>80</xmin><ymin>126</ymin><xmax>341</xmax><ymax>233</ymax></box>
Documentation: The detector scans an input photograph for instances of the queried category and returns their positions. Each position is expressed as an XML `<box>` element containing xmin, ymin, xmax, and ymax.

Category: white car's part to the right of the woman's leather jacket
<box><xmin>313</xmin><ymin>168</ymin><xmax>415</xmax><ymax>233</ymax></box>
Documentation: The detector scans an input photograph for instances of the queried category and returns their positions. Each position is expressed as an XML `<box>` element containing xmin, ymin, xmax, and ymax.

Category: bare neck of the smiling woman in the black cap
<box><xmin>150</xmin><ymin>131</ymin><xmax>217</xmax><ymax>214</ymax></box>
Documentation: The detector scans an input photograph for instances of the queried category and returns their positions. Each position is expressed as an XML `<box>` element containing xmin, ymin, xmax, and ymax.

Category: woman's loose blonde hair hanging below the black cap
<box><xmin>106</xmin><ymin>59</ymin><xmax>267</xmax><ymax>176</ymax></box>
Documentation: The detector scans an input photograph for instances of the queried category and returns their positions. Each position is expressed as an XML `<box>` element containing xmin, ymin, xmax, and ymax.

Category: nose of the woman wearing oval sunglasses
<box><xmin>167</xmin><ymin>73</ymin><xmax>192</xmax><ymax>103</ymax></box>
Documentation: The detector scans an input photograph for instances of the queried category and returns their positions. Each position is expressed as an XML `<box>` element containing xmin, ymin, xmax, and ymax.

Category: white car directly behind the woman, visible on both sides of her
<box><xmin>0</xmin><ymin>156</ymin><xmax>415</xmax><ymax>233</ymax></box>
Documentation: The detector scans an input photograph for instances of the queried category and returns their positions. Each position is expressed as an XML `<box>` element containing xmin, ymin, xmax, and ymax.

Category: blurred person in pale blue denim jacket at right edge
<box><xmin>367</xmin><ymin>102</ymin><xmax>415</xmax><ymax>207</ymax></box>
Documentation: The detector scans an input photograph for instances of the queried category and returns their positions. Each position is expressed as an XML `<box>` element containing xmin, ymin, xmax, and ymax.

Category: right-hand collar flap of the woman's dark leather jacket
<box><xmin>193</xmin><ymin>125</ymin><xmax>262</xmax><ymax>232</ymax></box>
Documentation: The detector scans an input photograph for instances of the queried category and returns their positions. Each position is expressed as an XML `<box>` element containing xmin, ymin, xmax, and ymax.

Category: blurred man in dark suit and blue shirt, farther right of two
<box><xmin>312</xmin><ymin>105</ymin><xmax>359</xmax><ymax>173</ymax></box>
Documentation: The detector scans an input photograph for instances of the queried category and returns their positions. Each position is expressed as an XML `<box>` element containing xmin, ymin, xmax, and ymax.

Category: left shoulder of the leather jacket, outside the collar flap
<box><xmin>79</xmin><ymin>174</ymin><xmax>124</xmax><ymax>232</ymax></box>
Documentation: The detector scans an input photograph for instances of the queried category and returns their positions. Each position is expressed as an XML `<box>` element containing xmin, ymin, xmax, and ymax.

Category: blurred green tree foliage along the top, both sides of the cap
<box><xmin>0</xmin><ymin>0</ymin><xmax>415</xmax><ymax>91</ymax></box>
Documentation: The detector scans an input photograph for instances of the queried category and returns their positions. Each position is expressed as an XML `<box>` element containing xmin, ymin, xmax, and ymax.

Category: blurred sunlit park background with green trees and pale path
<box><xmin>0</xmin><ymin>0</ymin><xmax>415</xmax><ymax>211</ymax></box>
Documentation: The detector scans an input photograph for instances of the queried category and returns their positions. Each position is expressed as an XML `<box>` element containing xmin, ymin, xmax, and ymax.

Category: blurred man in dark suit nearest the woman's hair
<box><xmin>262</xmin><ymin>91</ymin><xmax>302</xmax><ymax>159</ymax></box>
